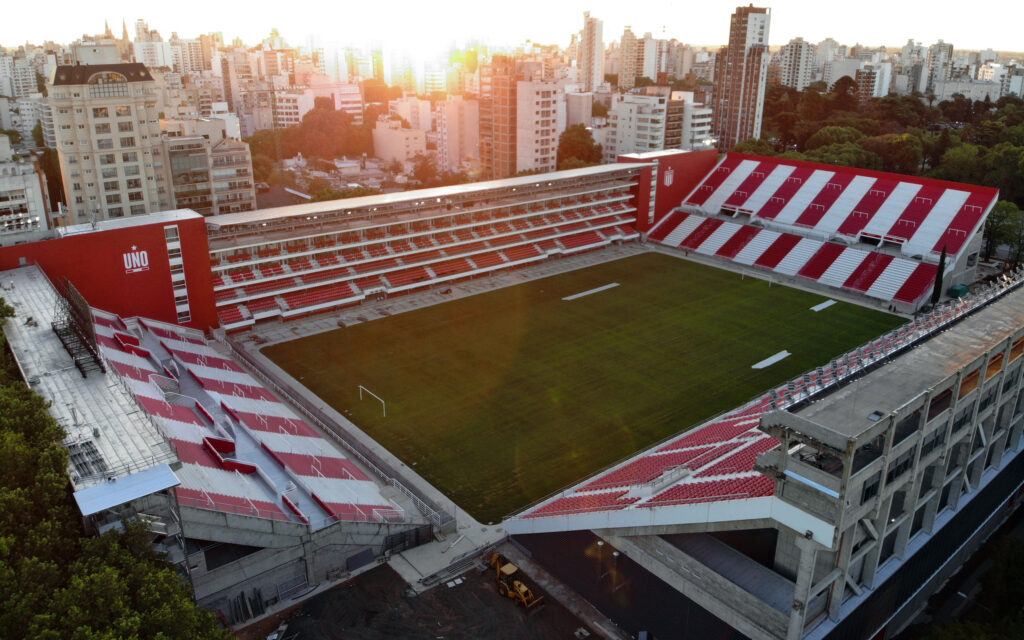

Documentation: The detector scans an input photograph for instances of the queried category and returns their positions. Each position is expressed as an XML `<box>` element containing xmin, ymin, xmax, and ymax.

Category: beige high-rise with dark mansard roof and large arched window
<box><xmin>49</xmin><ymin>62</ymin><xmax>171</xmax><ymax>223</ymax></box>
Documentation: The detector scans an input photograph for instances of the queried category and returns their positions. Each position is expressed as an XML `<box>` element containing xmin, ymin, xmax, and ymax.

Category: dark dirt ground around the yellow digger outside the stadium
<box><xmin>240</xmin><ymin>565</ymin><xmax>594</xmax><ymax>640</ymax></box>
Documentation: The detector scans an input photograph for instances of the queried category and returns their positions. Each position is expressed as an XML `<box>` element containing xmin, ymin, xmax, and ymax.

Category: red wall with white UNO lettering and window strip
<box><xmin>0</xmin><ymin>214</ymin><xmax>217</xmax><ymax>331</ymax></box>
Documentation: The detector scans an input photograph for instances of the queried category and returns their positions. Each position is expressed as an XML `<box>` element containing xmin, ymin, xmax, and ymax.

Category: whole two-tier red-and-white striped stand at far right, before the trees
<box><xmin>648</xmin><ymin>149</ymin><xmax>996</xmax><ymax>310</ymax></box>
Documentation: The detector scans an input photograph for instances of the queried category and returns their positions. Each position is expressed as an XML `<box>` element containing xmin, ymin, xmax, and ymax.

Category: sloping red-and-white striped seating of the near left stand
<box><xmin>95</xmin><ymin>313</ymin><xmax>407</xmax><ymax>527</ymax></box>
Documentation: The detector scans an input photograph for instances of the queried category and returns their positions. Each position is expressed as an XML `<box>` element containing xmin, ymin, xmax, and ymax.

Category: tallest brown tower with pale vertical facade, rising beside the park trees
<box><xmin>712</xmin><ymin>5</ymin><xmax>771</xmax><ymax>148</ymax></box>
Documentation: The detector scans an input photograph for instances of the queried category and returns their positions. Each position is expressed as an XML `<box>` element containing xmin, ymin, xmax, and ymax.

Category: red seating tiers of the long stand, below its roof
<box><xmin>212</xmin><ymin>184</ymin><xmax>639</xmax><ymax>323</ymax></box>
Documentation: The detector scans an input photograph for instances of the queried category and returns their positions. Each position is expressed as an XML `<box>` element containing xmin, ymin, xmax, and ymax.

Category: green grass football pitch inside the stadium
<box><xmin>263</xmin><ymin>253</ymin><xmax>903</xmax><ymax>522</ymax></box>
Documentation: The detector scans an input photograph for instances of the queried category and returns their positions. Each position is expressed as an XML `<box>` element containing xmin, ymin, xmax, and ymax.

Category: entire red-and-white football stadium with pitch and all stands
<box><xmin>0</xmin><ymin>152</ymin><xmax>1024</xmax><ymax>639</ymax></box>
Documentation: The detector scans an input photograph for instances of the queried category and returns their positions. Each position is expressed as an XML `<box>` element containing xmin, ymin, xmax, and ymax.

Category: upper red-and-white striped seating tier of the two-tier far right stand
<box><xmin>682</xmin><ymin>153</ymin><xmax>998</xmax><ymax>257</ymax></box>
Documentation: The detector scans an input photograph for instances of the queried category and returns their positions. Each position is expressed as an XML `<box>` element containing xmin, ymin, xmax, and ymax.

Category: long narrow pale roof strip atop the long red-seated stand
<box><xmin>206</xmin><ymin>163</ymin><xmax>645</xmax><ymax>229</ymax></box>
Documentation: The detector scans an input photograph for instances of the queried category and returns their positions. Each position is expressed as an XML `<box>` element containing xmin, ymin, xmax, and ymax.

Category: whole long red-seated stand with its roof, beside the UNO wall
<box><xmin>203</xmin><ymin>165</ymin><xmax>642</xmax><ymax>330</ymax></box>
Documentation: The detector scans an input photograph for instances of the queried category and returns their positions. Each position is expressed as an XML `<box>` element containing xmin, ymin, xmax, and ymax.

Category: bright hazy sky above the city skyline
<box><xmin>0</xmin><ymin>0</ymin><xmax>1024</xmax><ymax>51</ymax></box>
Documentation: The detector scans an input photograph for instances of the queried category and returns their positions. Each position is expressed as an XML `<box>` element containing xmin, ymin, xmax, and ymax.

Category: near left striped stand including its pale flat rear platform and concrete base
<box><xmin>3</xmin><ymin>266</ymin><xmax>433</xmax><ymax>621</ymax></box>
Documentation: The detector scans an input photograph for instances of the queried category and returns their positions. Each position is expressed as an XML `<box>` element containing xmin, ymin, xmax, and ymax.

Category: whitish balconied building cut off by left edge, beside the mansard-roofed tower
<box><xmin>0</xmin><ymin>134</ymin><xmax>49</xmax><ymax>245</ymax></box>
